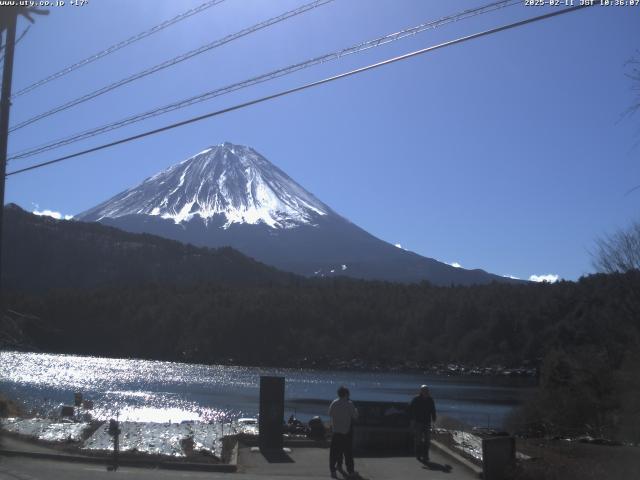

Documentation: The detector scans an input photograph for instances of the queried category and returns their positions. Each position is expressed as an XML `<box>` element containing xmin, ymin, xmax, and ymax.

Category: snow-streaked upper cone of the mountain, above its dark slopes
<box><xmin>78</xmin><ymin>142</ymin><xmax>331</xmax><ymax>229</ymax></box>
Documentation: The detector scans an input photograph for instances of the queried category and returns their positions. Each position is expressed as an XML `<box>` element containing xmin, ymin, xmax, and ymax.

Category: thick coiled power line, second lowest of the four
<box><xmin>9</xmin><ymin>0</ymin><xmax>520</xmax><ymax>160</ymax></box>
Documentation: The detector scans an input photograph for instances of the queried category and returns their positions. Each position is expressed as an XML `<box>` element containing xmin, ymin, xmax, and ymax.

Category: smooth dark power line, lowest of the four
<box><xmin>6</xmin><ymin>3</ymin><xmax>593</xmax><ymax>176</ymax></box>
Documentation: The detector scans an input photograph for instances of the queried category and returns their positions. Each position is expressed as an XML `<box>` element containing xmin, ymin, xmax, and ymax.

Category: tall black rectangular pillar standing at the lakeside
<box><xmin>258</xmin><ymin>377</ymin><xmax>284</xmax><ymax>452</ymax></box>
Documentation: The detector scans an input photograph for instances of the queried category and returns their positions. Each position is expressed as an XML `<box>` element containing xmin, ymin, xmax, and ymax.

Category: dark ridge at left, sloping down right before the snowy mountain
<box><xmin>2</xmin><ymin>205</ymin><xmax>295</xmax><ymax>292</ymax></box>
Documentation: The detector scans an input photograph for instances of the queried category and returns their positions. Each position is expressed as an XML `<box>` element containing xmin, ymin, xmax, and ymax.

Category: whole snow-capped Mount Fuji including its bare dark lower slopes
<box><xmin>75</xmin><ymin>142</ymin><xmax>513</xmax><ymax>285</ymax></box>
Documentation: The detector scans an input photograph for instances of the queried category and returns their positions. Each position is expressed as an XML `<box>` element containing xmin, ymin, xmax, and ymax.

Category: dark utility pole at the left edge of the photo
<box><xmin>0</xmin><ymin>8</ymin><xmax>19</xmax><ymax>298</ymax></box>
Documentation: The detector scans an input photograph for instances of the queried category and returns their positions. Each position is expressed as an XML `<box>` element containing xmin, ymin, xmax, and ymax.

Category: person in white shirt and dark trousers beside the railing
<box><xmin>329</xmin><ymin>386</ymin><xmax>358</xmax><ymax>478</ymax></box>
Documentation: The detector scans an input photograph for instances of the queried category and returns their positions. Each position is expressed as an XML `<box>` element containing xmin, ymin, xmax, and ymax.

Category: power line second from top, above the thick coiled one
<box><xmin>9</xmin><ymin>0</ymin><xmax>334</xmax><ymax>132</ymax></box>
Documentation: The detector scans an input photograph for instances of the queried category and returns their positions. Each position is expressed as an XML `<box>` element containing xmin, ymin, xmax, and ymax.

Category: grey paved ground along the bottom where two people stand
<box><xmin>0</xmin><ymin>448</ymin><xmax>477</xmax><ymax>480</ymax></box>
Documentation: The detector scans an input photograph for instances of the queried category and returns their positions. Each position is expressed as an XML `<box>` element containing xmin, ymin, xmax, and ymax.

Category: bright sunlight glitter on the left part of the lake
<box><xmin>0</xmin><ymin>352</ymin><xmax>252</xmax><ymax>423</ymax></box>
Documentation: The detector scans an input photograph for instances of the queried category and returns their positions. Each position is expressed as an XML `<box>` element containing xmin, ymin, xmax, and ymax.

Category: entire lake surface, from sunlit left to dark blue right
<box><xmin>0</xmin><ymin>352</ymin><xmax>532</xmax><ymax>427</ymax></box>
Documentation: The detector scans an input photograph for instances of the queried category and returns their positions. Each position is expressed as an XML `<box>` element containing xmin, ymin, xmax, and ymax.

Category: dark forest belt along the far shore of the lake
<box><xmin>9</xmin><ymin>272</ymin><xmax>640</xmax><ymax>372</ymax></box>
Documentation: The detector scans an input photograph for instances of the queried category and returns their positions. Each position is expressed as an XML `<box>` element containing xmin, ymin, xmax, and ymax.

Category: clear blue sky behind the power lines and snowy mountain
<box><xmin>5</xmin><ymin>0</ymin><xmax>640</xmax><ymax>279</ymax></box>
